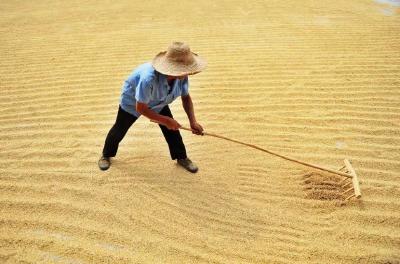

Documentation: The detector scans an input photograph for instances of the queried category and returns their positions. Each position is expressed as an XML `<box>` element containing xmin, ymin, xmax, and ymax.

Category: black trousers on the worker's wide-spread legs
<box><xmin>103</xmin><ymin>105</ymin><xmax>187</xmax><ymax>160</ymax></box>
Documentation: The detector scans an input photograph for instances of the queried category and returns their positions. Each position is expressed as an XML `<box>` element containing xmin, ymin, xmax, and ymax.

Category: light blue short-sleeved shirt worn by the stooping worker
<box><xmin>120</xmin><ymin>62</ymin><xmax>189</xmax><ymax>117</ymax></box>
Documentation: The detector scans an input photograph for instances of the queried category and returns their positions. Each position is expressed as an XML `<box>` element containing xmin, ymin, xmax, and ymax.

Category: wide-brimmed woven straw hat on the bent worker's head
<box><xmin>152</xmin><ymin>42</ymin><xmax>207</xmax><ymax>76</ymax></box>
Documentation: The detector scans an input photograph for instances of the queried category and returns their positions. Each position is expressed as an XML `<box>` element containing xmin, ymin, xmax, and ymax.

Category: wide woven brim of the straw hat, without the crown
<box><xmin>151</xmin><ymin>51</ymin><xmax>207</xmax><ymax>76</ymax></box>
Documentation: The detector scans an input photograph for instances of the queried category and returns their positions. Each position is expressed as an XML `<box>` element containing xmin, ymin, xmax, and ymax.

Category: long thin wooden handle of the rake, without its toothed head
<box><xmin>151</xmin><ymin>120</ymin><xmax>353</xmax><ymax>178</ymax></box>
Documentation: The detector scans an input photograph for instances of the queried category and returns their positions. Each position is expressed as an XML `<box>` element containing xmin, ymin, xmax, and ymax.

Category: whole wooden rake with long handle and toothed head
<box><xmin>151</xmin><ymin>120</ymin><xmax>361</xmax><ymax>201</ymax></box>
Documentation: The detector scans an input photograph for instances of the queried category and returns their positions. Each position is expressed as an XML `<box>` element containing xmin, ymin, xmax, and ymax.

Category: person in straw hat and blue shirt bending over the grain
<box><xmin>98</xmin><ymin>42</ymin><xmax>206</xmax><ymax>173</ymax></box>
